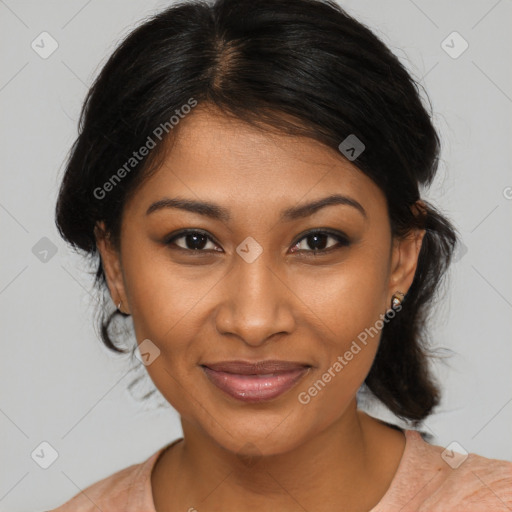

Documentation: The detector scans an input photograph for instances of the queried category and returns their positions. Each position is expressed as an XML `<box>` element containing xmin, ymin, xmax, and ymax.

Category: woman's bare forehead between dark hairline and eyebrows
<box><xmin>123</xmin><ymin>107</ymin><xmax>385</xmax><ymax>219</ymax></box>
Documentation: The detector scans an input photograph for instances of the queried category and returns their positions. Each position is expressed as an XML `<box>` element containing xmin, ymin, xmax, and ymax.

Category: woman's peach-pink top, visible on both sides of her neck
<box><xmin>50</xmin><ymin>430</ymin><xmax>512</xmax><ymax>512</ymax></box>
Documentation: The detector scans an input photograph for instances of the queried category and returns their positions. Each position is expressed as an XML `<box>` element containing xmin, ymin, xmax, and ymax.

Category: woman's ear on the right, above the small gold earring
<box><xmin>387</xmin><ymin>201</ymin><xmax>426</xmax><ymax>307</ymax></box>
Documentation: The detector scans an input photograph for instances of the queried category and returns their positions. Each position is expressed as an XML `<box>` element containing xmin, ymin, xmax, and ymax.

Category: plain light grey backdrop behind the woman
<box><xmin>0</xmin><ymin>0</ymin><xmax>512</xmax><ymax>512</ymax></box>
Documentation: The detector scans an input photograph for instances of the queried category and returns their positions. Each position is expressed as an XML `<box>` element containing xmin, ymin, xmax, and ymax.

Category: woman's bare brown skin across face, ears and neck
<box><xmin>97</xmin><ymin>107</ymin><xmax>424</xmax><ymax>512</ymax></box>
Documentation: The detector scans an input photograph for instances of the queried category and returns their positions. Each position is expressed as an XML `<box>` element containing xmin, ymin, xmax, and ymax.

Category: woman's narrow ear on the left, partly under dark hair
<box><xmin>94</xmin><ymin>221</ymin><xmax>129</xmax><ymax>314</ymax></box>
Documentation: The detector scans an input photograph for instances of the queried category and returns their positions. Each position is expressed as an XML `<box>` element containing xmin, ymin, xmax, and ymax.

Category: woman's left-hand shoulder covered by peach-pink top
<box><xmin>49</xmin><ymin>447</ymin><xmax>165</xmax><ymax>512</ymax></box>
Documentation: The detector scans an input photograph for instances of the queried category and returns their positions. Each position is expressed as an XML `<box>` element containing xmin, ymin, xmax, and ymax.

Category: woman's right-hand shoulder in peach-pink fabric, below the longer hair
<box><xmin>372</xmin><ymin>430</ymin><xmax>512</xmax><ymax>512</ymax></box>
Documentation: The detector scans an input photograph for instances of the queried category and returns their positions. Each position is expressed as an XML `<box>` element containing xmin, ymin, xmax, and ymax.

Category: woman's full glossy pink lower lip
<box><xmin>202</xmin><ymin>366</ymin><xmax>309</xmax><ymax>402</ymax></box>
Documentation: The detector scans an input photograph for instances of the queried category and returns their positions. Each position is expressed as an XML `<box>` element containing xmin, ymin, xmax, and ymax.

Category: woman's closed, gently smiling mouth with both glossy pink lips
<box><xmin>201</xmin><ymin>360</ymin><xmax>311</xmax><ymax>403</ymax></box>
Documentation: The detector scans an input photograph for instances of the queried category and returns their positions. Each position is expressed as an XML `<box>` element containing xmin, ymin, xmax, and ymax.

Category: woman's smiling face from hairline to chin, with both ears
<box><xmin>99</xmin><ymin>109</ymin><xmax>421</xmax><ymax>454</ymax></box>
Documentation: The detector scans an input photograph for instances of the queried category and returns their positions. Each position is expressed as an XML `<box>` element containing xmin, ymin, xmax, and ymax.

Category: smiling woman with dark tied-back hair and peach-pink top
<box><xmin>50</xmin><ymin>0</ymin><xmax>512</xmax><ymax>512</ymax></box>
